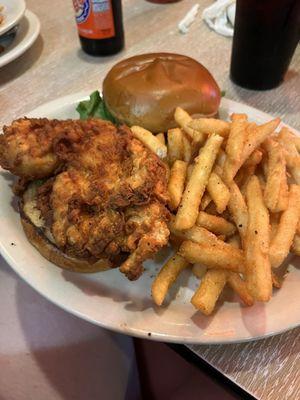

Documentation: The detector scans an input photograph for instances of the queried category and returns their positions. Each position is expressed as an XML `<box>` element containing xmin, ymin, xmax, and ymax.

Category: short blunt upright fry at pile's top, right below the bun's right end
<box><xmin>226</xmin><ymin>114</ymin><xmax>248</xmax><ymax>162</ymax></box>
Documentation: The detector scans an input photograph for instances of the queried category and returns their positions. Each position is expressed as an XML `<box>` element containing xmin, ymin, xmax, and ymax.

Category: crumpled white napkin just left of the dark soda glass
<box><xmin>202</xmin><ymin>0</ymin><xmax>235</xmax><ymax>36</ymax></box>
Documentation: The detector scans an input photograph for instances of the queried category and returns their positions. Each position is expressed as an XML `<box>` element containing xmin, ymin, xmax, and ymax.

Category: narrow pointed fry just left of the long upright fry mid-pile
<box><xmin>228</xmin><ymin>182</ymin><xmax>248</xmax><ymax>241</ymax></box>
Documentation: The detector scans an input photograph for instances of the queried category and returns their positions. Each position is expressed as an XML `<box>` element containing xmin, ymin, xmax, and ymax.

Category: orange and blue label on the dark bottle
<box><xmin>73</xmin><ymin>0</ymin><xmax>115</xmax><ymax>39</ymax></box>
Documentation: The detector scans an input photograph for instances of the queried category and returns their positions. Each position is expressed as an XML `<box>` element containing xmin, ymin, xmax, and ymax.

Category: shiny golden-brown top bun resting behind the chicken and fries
<box><xmin>103</xmin><ymin>53</ymin><xmax>221</xmax><ymax>133</ymax></box>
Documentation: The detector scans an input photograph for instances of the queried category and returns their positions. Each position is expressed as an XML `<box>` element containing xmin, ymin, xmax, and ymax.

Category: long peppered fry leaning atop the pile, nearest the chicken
<box><xmin>175</xmin><ymin>135</ymin><xmax>223</xmax><ymax>230</ymax></box>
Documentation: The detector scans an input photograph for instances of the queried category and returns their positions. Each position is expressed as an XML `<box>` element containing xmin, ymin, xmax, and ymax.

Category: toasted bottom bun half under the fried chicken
<box><xmin>19</xmin><ymin>183</ymin><xmax>113</xmax><ymax>273</ymax></box>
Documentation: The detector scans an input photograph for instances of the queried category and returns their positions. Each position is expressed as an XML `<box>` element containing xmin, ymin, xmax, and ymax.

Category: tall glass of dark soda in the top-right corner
<box><xmin>230</xmin><ymin>0</ymin><xmax>300</xmax><ymax>90</ymax></box>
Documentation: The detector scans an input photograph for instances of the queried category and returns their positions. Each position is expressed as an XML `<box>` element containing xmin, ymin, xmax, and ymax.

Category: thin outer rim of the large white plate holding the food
<box><xmin>0</xmin><ymin>90</ymin><xmax>300</xmax><ymax>345</ymax></box>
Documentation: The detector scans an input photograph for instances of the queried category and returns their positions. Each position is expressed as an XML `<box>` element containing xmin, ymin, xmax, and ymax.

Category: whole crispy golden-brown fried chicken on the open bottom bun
<box><xmin>0</xmin><ymin>118</ymin><xmax>169</xmax><ymax>280</ymax></box>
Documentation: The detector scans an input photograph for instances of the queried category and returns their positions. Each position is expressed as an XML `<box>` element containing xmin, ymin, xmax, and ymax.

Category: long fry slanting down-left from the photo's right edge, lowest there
<box><xmin>270</xmin><ymin>185</ymin><xmax>300</xmax><ymax>268</ymax></box>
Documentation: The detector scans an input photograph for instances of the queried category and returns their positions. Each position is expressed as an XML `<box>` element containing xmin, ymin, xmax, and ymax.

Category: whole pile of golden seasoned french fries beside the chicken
<box><xmin>142</xmin><ymin>107</ymin><xmax>300</xmax><ymax>315</ymax></box>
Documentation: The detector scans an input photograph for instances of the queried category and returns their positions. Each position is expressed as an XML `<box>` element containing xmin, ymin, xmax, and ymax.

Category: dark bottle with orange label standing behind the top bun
<box><xmin>73</xmin><ymin>0</ymin><xmax>124</xmax><ymax>56</ymax></box>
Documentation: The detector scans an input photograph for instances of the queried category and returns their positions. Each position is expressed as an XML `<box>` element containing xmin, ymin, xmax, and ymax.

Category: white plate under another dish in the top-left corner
<box><xmin>0</xmin><ymin>9</ymin><xmax>40</xmax><ymax>68</ymax></box>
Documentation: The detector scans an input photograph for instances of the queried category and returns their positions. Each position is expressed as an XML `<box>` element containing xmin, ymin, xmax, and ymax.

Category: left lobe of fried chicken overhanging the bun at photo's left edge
<box><xmin>0</xmin><ymin>118</ymin><xmax>116</xmax><ymax>180</ymax></box>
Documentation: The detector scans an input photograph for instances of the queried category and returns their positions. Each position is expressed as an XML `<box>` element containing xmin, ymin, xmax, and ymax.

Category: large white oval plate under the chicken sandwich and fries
<box><xmin>0</xmin><ymin>93</ymin><xmax>300</xmax><ymax>344</ymax></box>
